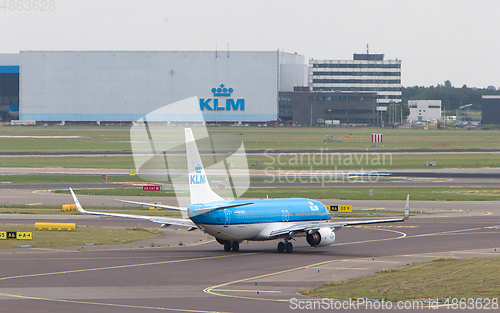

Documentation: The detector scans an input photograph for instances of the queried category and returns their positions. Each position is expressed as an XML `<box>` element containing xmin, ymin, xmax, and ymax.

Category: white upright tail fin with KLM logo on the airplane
<box><xmin>184</xmin><ymin>128</ymin><xmax>224</xmax><ymax>204</ymax></box>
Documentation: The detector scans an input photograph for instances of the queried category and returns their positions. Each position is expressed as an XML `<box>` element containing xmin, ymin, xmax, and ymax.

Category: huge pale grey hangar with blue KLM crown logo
<box><xmin>0</xmin><ymin>51</ymin><xmax>308</xmax><ymax>122</ymax></box>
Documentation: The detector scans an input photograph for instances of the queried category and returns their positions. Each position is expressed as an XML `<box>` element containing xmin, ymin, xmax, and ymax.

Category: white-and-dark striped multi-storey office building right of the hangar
<box><xmin>309</xmin><ymin>54</ymin><xmax>401</xmax><ymax>106</ymax></box>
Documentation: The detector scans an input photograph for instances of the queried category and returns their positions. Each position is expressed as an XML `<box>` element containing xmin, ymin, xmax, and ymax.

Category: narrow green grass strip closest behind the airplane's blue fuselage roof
<box><xmin>56</xmin><ymin>187</ymin><xmax>500</xmax><ymax>201</ymax></box>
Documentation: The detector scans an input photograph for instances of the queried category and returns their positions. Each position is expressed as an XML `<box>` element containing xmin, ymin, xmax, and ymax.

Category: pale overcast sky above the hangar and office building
<box><xmin>0</xmin><ymin>0</ymin><xmax>500</xmax><ymax>88</ymax></box>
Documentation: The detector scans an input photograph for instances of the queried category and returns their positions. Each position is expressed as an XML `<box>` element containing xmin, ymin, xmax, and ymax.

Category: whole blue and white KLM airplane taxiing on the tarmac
<box><xmin>70</xmin><ymin>128</ymin><xmax>410</xmax><ymax>253</ymax></box>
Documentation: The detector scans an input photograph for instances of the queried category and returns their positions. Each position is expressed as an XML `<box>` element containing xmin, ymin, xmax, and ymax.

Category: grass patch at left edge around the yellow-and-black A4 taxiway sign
<box><xmin>0</xmin><ymin>225</ymin><xmax>163</xmax><ymax>248</ymax></box>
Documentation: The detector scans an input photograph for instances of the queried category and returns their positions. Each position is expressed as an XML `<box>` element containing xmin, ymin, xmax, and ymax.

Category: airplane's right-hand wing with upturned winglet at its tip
<box><xmin>270</xmin><ymin>195</ymin><xmax>410</xmax><ymax>237</ymax></box>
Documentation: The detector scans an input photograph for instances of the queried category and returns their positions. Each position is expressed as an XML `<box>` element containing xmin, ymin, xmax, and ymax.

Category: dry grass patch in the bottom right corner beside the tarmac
<box><xmin>302</xmin><ymin>257</ymin><xmax>500</xmax><ymax>301</ymax></box>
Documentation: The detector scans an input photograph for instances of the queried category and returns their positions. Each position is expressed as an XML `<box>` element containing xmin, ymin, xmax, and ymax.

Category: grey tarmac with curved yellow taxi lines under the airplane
<box><xmin>0</xmin><ymin>200</ymin><xmax>500</xmax><ymax>313</ymax></box>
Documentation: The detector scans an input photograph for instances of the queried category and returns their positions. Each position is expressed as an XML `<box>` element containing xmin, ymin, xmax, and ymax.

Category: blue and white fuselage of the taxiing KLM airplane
<box><xmin>188</xmin><ymin>198</ymin><xmax>331</xmax><ymax>241</ymax></box>
